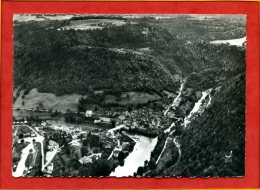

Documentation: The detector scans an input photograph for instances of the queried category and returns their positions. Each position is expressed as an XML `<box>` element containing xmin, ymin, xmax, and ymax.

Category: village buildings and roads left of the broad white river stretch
<box><xmin>13</xmin><ymin>98</ymin><xmax>175</xmax><ymax>177</ymax></box>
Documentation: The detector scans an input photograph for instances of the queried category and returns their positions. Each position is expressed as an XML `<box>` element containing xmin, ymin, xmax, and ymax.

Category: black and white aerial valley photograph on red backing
<box><xmin>10</xmin><ymin>14</ymin><xmax>246</xmax><ymax>178</ymax></box>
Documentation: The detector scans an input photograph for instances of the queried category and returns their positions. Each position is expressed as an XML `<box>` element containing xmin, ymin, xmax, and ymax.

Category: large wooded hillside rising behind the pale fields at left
<box><xmin>14</xmin><ymin>19</ymin><xmax>181</xmax><ymax>95</ymax></box>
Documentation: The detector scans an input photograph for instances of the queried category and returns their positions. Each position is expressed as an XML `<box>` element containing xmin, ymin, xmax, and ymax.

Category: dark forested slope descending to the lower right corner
<box><xmin>159</xmin><ymin>74</ymin><xmax>245</xmax><ymax>177</ymax></box>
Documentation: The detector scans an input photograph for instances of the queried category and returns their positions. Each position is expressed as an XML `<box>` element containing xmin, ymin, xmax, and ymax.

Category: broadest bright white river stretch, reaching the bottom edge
<box><xmin>110</xmin><ymin>134</ymin><xmax>158</xmax><ymax>177</ymax></box>
